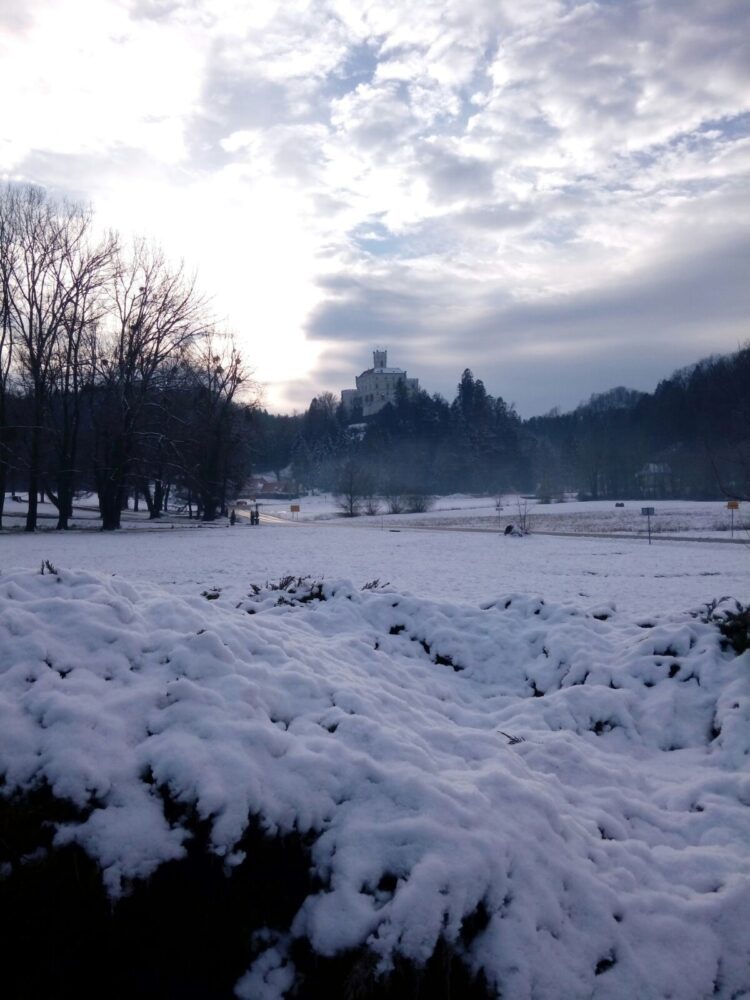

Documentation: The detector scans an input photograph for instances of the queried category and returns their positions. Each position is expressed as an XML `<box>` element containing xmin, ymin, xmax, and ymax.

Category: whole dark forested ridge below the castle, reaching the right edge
<box><xmin>255</xmin><ymin>345</ymin><xmax>750</xmax><ymax>499</ymax></box>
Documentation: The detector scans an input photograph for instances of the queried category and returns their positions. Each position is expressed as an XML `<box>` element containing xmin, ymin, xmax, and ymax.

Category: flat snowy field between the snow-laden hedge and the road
<box><xmin>0</xmin><ymin>508</ymin><xmax>750</xmax><ymax>614</ymax></box>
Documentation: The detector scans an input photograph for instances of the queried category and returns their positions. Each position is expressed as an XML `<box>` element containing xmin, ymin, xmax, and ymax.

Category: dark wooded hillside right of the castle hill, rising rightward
<box><xmin>525</xmin><ymin>345</ymin><xmax>750</xmax><ymax>500</ymax></box>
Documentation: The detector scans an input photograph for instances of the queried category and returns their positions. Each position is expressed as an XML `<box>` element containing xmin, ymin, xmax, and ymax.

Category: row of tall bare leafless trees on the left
<box><xmin>0</xmin><ymin>185</ymin><xmax>252</xmax><ymax>531</ymax></box>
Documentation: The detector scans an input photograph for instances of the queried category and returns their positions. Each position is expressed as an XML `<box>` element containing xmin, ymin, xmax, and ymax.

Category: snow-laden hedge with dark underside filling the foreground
<box><xmin>0</xmin><ymin>567</ymin><xmax>750</xmax><ymax>1000</ymax></box>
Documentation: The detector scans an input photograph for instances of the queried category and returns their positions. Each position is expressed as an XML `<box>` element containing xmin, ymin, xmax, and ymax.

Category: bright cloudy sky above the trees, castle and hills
<box><xmin>0</xmin><ymin>0</ymin><xmax>750</xmax><ymax>417</ymax></box>
